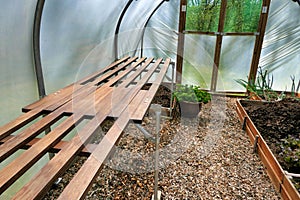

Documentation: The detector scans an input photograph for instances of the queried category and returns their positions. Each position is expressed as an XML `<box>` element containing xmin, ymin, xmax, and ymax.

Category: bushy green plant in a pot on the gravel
<box><xmin>173</xmin><ymin>84</ymin><xmax>211</xmax><ymax>118</ymax></box>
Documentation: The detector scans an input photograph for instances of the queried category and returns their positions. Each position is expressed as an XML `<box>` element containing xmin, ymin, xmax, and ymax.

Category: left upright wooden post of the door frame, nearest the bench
<box><xmin>176</xmin><ymin>0</ymin><xmax>187</xmax><ymax>83</ymax></box>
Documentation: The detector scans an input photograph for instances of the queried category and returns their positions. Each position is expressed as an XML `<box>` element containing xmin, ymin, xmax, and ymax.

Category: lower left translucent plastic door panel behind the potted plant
<box><xmin>182</xmin><ymin>34</ymin><xmax>216</xmax><ymax>89</ymax></box>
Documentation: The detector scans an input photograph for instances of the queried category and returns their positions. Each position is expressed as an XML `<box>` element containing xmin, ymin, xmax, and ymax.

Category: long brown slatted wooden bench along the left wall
<box><xmin>0</xmin><ymin>57</ymin><xmax>170</xmax><ymax>200</ymax></box>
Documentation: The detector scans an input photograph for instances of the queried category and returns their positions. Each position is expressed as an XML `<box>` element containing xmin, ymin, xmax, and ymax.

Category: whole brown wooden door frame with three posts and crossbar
<box><xmin>176</xmin><ymin>0</ymin><xmax>271</xmax><ymax>92</ymax></box>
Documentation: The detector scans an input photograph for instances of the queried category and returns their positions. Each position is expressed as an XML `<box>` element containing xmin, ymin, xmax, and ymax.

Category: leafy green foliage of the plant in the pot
<box><xmin>173</xmin><ymin>84</ymin><xmax>211</xmax><ymax>103</ymax></box>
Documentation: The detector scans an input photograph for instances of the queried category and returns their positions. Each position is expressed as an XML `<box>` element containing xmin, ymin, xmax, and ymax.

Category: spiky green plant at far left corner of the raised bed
<box><xmin>235</xmin><ymin>67</ymin><xmax>284</xmax><ymax>101</ymax></box>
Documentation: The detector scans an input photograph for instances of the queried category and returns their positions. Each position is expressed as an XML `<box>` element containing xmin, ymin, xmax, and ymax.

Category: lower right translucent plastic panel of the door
<box><xmin>217</xmin><ymin>36</ymin><xmax>255</xmax><ymax>92</ymax></box>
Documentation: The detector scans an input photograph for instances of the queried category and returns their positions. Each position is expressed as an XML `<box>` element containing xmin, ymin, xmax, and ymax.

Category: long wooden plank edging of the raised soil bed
<box><xmin>236</xmin><ymin>100</ymin><xmax>300</xmax><ymax>200</ymax></box>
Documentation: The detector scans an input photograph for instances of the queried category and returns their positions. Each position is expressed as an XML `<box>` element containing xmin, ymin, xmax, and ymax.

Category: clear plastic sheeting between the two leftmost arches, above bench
<box><xmin>41</xmin><ymin>0</ymin><xmax>127</xmax><ymax>94</ymax></box>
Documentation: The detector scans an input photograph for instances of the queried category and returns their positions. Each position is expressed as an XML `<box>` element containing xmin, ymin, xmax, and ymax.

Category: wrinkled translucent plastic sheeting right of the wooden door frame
<box><xmin>259</xmin><ymin>0</ymin><xmax>300</xmax><ymax>91</ymax></box>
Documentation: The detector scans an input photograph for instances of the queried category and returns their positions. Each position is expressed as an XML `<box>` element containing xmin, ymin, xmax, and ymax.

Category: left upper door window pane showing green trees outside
<box><xmin>186</xmin><ymin>0</ymin><xmax>221</xmax><ymax>32</ymax></box>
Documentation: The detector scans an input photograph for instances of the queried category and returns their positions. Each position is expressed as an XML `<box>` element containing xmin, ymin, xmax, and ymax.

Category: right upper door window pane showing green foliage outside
<box><xmin>224</xmin><ymin>0</ymin><xmax>262</xmax><ymax>32</ymax></box>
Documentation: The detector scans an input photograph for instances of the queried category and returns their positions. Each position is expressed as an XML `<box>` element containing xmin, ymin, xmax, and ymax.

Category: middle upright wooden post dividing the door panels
<box><xmin>210</xmin><ymin>0</ymin><xmax>227</xmax><ymax>92</ymax></box>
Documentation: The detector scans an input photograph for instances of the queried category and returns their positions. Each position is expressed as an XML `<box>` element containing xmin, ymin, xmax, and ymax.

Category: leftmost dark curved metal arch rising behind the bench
<box><xmin>33</xmin><ymin>0</ymin><xmax>46</xmax><ymax>99</ymax></box>
